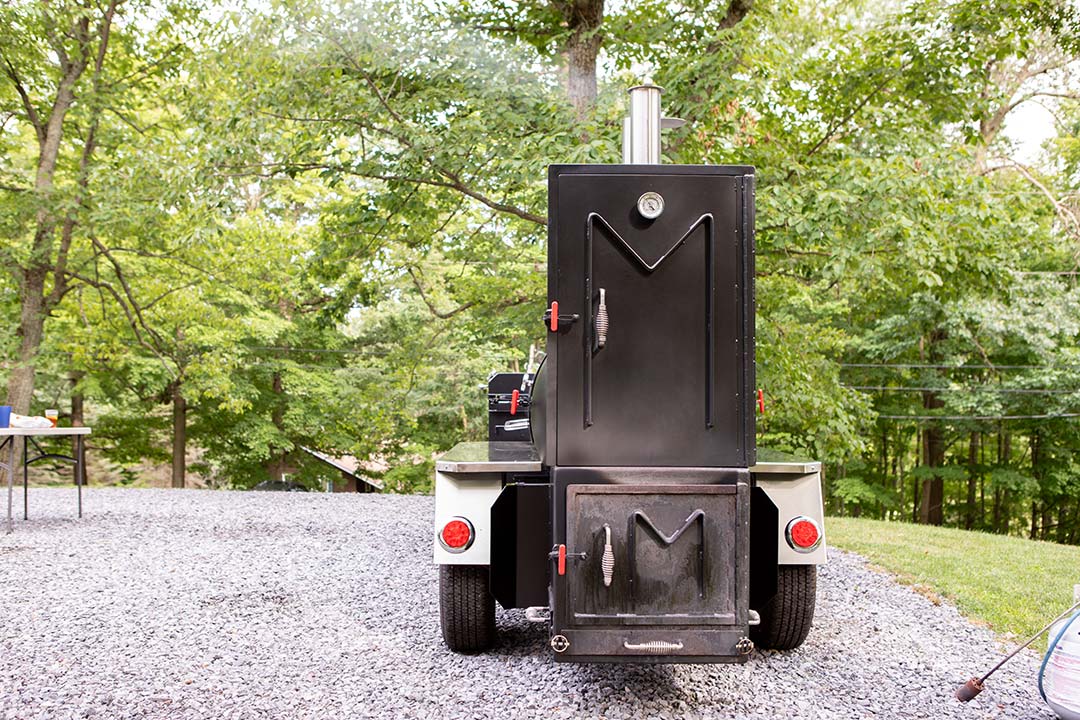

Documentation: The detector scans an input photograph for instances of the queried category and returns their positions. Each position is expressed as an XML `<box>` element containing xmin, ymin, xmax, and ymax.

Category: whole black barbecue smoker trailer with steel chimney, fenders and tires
<box><xmin>433</xmin><ymin>85</ymin><xmax>825</xmax><ymax>663</ymax></box>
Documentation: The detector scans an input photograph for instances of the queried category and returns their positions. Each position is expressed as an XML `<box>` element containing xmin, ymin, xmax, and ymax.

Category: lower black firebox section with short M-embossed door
<box><xmin>553</xmin><ymin>467</ymin><xmax>750</xmax><ymax>662</ymax></box>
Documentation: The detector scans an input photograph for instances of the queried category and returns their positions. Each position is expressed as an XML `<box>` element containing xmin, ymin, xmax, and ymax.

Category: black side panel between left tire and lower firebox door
<box><xmin>491</xmin><ymin>484</ymin><xmax>551</xmax><ymax>608</ymax></box>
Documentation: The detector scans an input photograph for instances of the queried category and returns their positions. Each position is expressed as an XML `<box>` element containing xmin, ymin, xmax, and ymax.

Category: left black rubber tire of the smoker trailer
<box><xmin>438</xmin><ymin>565</ymin><xmax>495</xmax><ymax>652</ymax></box>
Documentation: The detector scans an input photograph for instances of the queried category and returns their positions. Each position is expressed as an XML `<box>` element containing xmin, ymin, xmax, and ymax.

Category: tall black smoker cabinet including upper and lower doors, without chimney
<box><xmin>532</xmin><ymin>165</ymin><xmax>755</xmax><ymax>661</ymax></box>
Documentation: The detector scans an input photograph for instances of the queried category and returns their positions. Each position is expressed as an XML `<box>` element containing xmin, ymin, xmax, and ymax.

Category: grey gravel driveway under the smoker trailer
<box><xmin>0</xmin><ymin>488</ymin><xmax>1053</xmax><ymax>719</ymax></box>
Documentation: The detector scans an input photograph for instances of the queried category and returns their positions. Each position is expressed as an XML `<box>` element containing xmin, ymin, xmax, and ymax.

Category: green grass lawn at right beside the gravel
<box><xmin>825</xmin><ymin>517</ymin><xmax>1080</xmax><ymax>639</ymax></box>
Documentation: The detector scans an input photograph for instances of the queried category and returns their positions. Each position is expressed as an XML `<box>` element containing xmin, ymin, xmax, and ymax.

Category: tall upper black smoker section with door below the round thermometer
<box><xmin>545</xmin><ymin>165</ymin><xmax>754</xmax><ymax>467</ymax></box>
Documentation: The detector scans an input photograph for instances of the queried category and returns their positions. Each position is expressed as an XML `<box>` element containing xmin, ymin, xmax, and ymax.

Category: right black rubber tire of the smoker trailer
<box><xmin>750</xmin><ymin>565</ymin><xmax>818</xmax><ymax>650</ymax></box>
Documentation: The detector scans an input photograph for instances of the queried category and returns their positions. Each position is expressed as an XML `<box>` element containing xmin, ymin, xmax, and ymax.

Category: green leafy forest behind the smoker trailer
<box><xmin>0</xmin><ymin>0</ymin><xmax>1080</xmax><ymax>544</ymax></box>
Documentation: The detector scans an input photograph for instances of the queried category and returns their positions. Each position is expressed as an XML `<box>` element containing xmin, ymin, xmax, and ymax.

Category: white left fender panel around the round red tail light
<box><xmin>432</xmin><ymin>471</ymin><xmax>502</xmax><ymax>565</ymax></box>
